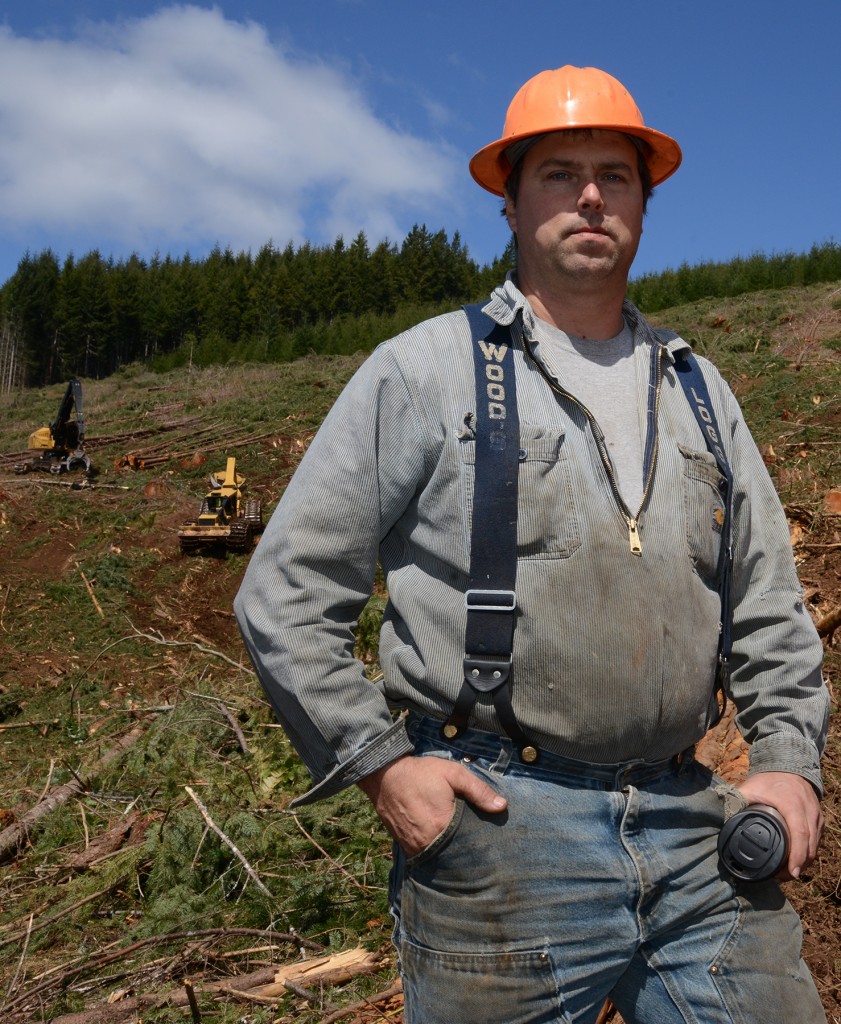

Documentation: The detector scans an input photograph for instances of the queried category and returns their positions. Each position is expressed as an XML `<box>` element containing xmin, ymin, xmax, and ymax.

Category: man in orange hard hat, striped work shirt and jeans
<box><xmin>236</xmin><ymin>67</ymin><xmax>828</xmax><ymax>1024</ymax></box>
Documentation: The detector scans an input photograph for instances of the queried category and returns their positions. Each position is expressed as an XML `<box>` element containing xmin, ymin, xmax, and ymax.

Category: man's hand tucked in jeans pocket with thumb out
<box><xmin>359</xmin><ymin>756</ymin><xmax>508</xmax><ymax>857</ymax></box>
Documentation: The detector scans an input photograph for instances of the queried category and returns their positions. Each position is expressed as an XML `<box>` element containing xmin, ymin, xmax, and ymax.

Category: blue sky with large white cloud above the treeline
<box><xmin>0</xmin><ymin>0</ymin><xmax>841</xmax><ymax>283</ymax></box>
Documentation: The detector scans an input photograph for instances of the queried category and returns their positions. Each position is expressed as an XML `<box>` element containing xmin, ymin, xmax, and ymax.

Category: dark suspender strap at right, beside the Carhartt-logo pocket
<box><xmin>675</xmin><ymin>352</ymin><xmax>733</xmax><ymax>724</ymax></box>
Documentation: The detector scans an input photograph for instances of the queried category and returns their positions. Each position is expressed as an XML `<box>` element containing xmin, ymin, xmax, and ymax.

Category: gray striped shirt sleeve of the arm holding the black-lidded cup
<box><xmin>722</xmin><ymin>372</ymin><xmax>830</xmax><ymax>793</ymax></box>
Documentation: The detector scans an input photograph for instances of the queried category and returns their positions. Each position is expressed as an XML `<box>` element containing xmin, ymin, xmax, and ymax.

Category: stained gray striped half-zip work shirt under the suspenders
<box><xmin>235</xmin><ymin>280</ymin><xmax>829</xmax><ymax>802</ymax></box>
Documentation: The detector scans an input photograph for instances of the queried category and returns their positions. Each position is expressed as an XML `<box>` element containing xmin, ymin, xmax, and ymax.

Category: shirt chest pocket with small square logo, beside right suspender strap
<box><xmin>678</xmin><ymin>445</ymin><xmax>727</xmax><ymax>581</ymax></box>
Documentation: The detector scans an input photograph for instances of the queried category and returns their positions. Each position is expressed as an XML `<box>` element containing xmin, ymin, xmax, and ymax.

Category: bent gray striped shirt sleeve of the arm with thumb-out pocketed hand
<box><xmin>235</xmin><ymin>344</ymin><xmax>424</xmax><ymax>803</ymax></box>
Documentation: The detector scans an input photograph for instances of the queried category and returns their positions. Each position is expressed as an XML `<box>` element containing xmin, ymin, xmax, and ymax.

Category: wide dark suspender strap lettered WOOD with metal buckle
<box><xmin>444</xmin><ymin>305</ymin><xmax>538</xmax><ymax>761</ymax></box>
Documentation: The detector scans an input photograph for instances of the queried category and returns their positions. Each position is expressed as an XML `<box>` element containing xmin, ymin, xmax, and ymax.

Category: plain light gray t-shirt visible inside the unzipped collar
<box><xmin>536</xmin><ymin>319</ymin><xmax>643</xmax><ymax>515</ymax></box>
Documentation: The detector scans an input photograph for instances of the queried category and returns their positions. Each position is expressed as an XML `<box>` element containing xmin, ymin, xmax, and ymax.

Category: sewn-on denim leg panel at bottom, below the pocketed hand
<box><xmin>401</xmin><ymin>938</ymin><xmax>570</xmax><ymax>1024</ymax></box>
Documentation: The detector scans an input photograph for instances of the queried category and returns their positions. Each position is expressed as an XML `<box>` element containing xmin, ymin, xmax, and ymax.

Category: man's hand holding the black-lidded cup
<box><xmin>739</xmin><ymin>771</ymin><xmax>824</xmax><ymax>882</ymax></box>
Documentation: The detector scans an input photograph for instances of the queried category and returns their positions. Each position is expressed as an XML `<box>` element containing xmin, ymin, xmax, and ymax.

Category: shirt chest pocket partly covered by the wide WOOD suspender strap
<box><xmin>460</xmin><ymin>423</ymin><xmax>581</xmax><ymax>558</ymax></box>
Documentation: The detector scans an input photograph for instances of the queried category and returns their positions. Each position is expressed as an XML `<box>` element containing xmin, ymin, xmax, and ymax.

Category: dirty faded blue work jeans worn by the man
<box><xmin>391</xmin><ymin>718</ymin><xmax>826</xmax><ymax>1024</ymax></box>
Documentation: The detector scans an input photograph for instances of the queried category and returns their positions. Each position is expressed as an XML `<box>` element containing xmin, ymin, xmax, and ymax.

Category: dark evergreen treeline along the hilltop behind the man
<box><xmin>0</xmin><ymin>225</ymin><xmax>841</xmax><ymax>391</ymax></box>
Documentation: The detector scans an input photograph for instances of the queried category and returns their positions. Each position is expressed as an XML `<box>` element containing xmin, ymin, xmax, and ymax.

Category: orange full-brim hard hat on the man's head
<box><xmin>470</xmin><ymin>65</ymin><xmax>682</xmax><ymax>196</ymax></box>
